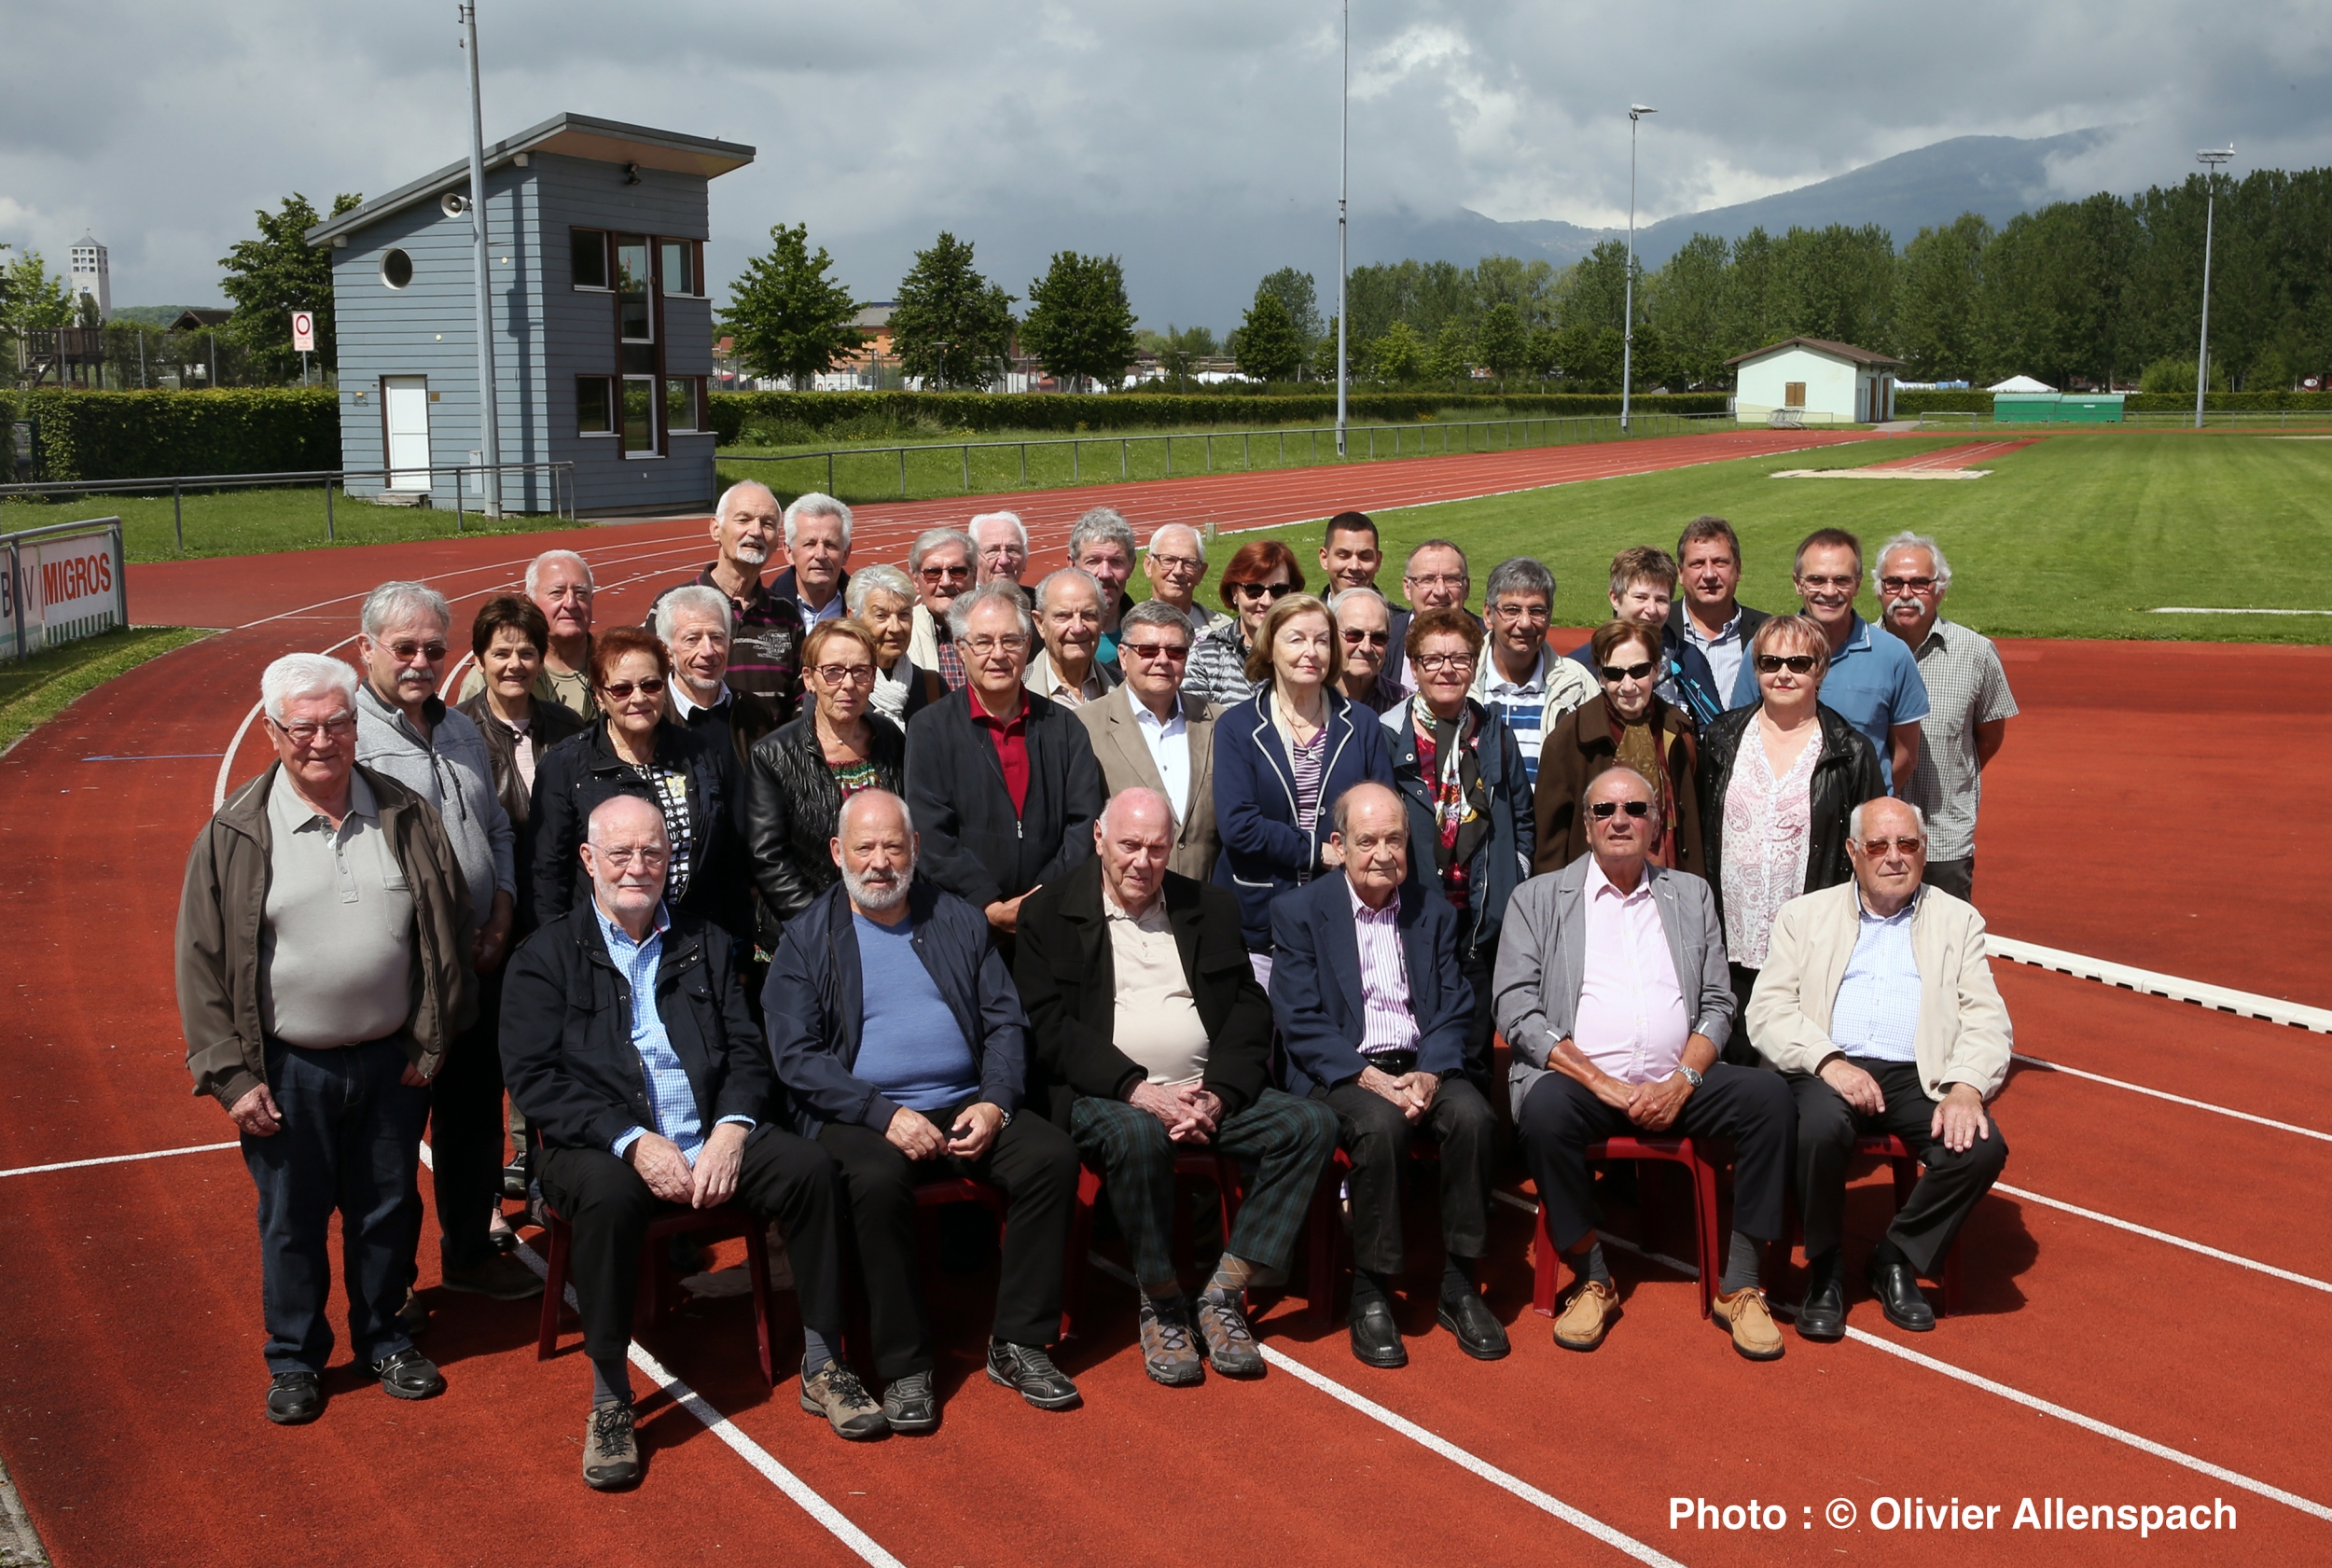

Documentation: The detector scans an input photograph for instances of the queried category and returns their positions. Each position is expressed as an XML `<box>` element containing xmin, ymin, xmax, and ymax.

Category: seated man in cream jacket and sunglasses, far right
<box><xmin>1749</xmin><ymin>796</ymin><xmax>2013</xmax><ymax>1339</ymax></box>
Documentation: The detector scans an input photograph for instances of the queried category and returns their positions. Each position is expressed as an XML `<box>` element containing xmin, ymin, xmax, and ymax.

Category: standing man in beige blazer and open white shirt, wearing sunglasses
<box><xmin>1077</xmin><ymin>600</ymin><xmax>1222</xmax><ymax>882</ymax></box>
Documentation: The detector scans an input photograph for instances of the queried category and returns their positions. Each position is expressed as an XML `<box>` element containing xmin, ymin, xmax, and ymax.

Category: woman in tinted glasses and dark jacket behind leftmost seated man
<box><xmin>532</xmin><ymin>625</ymin><xmax>754</xmax><ymax>942</ymax></box>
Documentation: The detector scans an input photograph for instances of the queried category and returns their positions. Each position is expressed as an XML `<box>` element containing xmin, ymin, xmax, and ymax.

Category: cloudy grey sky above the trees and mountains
<box><xmin>13</xmin><ymin>0</ymin><xmax>2332</xmax><ymax>329</ymax></box>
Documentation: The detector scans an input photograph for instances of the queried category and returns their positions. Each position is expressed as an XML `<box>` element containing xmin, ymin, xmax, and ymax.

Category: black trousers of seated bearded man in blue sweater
<box><xmin>819</xmin><ymin>1102</ymin><xmax>1077</xmax><ymax>1381</ymax></box>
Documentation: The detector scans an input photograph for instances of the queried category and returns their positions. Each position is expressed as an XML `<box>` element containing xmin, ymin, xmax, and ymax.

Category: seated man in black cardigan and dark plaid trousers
<box><xmin>1012</xmin><ymin>798</ymin><xmax>1337</xmax><ymax>1388</ymax></box>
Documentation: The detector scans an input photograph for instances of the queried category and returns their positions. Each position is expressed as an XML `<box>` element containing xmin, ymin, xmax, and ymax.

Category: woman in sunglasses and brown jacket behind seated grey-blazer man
<box><xmin>1533</xmin><ymin>620</ymin><xmax>1700</xmax><ymax>875</ymax></box>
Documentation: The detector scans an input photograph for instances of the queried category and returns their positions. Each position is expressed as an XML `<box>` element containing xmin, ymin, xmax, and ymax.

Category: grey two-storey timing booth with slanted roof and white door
<box><xmin>308</xmin><ymin>115</ymin><xmax>754</xmax><ymax>516</ymax></box>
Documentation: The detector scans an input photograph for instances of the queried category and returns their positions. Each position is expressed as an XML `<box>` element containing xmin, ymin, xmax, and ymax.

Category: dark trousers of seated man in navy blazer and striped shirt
<box><xmin>1313</xmin><ymin>1075</ymin><xmax>1497</xmax><ymax>1274</ymax></box>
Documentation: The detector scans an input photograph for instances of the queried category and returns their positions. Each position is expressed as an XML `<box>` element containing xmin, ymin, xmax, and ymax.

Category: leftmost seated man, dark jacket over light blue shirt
<box><xmin>502</xmin><ymin>796</ymin><xmax>886</xmax><ymax>1491</ymax></box>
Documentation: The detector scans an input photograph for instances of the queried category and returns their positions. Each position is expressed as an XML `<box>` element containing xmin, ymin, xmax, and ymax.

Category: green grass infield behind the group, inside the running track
<box><xmin>1211</xmin><ymin>432</ymin><xmax>2332</xmax><ymax>644</ymax></box>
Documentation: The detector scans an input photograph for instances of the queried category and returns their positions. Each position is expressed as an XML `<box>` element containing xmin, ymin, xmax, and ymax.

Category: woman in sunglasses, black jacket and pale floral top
<box><xmin>1698</xmin><ymin>616</ymin><xmax>1887</xmax><ymax>1062</ymax></box>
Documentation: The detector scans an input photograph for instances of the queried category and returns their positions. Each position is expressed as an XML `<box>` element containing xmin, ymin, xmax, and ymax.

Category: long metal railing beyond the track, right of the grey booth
<box><xmin>716</xmin><ymin>413</ymin><xmax>1733</xmax><ymax>499</ymax></box>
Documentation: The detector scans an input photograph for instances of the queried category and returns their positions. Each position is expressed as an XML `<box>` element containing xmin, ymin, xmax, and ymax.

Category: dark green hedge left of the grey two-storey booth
<box><xmin>21</xmin><ymin>387</ymin><xmax>340</xmax><ymax>480</ymax></box>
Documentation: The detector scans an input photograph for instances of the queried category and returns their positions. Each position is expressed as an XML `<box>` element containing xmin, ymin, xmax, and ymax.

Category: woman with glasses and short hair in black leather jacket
<box><xmin>744</xmin><ymin>620</ymin><xmax>908</xmax><ymax>952</ymax></box>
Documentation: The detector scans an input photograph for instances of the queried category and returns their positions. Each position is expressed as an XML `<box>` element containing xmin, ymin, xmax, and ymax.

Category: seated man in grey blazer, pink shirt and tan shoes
<box><xmin>1491</xmin><ymin>768</ymin><xmax>1798</xmax><ymax>1360</ymax></box>
